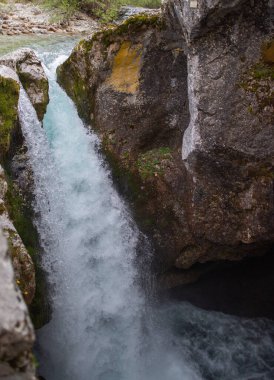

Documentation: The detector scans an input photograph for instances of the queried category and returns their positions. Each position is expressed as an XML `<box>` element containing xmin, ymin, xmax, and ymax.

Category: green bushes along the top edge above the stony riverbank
<box><xmin>39</xmin><ymin>0</ymin><xmax>161</xmax><ymax>22</ymax></box>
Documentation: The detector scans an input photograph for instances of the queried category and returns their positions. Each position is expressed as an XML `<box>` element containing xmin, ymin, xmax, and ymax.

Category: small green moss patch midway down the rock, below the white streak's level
<box><xmin>137</xmin><ymin>147</ymin><xmax>172</xmax><ymax>180</ymax></box>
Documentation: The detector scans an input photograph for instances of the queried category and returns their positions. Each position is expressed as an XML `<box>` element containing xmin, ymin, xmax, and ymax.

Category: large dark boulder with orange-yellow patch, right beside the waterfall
<box><xmin>57</xmin><ymin>14</ymin><xmax>189</xmax><ymax>265</ymax></box>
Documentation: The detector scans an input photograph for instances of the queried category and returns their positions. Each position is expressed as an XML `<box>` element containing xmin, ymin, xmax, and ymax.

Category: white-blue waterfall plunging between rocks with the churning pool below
<box><xmin>17</xmin><ymin>40</ymin><xmax>274</xmax><ymax>380</ymax></box>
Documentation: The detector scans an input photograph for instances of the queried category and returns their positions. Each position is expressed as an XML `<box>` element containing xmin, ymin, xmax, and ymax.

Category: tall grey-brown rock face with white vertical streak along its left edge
<box><xmin>164</xmin><ymin>0</ymin><xmax>274</xmax><ymax>266</ymax></box>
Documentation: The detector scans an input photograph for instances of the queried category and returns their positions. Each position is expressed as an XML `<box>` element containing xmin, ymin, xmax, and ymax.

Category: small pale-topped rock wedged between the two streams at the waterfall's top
<box><xmin>0</xmin><ymin>48</ymin><xmax>49</xmax><ymax>120</ymax></box>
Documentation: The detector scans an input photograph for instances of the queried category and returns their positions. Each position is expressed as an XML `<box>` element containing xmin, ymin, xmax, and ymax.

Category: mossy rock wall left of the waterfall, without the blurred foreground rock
<box><xmin>0</xmin><ymin>49</ymin><xmax>48</xmax><ymax>326</ymax></box>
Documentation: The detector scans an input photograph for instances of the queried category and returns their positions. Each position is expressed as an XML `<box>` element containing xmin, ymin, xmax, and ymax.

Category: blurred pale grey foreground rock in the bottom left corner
<box><xmin>0</xmin><ymin>232</ymin><xmax>35</xmax><ymax>380</ymax></box>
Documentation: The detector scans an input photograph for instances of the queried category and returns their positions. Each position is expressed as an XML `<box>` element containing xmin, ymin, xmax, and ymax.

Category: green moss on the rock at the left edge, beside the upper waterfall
<box><xmin>0</xmin><ymin>76</ymin><xmax>20</xmax><ymax>157</ymax></box>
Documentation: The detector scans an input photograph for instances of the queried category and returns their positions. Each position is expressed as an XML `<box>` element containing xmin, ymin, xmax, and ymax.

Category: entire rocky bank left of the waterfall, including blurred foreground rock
<box><xmin>0</xmin><ymin>49</ymin><xmax>48</xmax><ymax>380</ymax></box>
